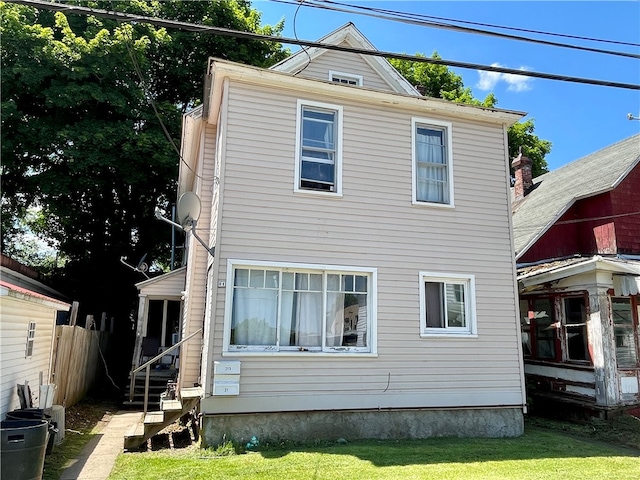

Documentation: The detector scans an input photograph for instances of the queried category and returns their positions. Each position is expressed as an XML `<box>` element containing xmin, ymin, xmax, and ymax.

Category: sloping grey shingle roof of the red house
<box><xmin>513</xmin><ymin>134</ymin><xmax>640</xmax><ymax>258</ymax></box>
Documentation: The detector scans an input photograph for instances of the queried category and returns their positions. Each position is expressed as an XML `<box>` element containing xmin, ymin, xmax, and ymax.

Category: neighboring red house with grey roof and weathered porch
<box><xmin>512</xmin><ymin>135</ymin><xmax>640</xmax><ymax>413</ymax></box>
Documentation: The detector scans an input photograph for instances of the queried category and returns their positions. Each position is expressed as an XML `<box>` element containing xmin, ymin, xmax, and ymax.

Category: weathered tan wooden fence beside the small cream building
<box><xmin>52</xmin><ymin>325</ymin><xmax>110</xmax><ymax>408</ymax></box>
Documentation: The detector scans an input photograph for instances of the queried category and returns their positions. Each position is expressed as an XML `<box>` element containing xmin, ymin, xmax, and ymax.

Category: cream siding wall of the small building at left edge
<box><xmin>0</xmin><ymin>293</ymin><xmax>58</xmax><ymax>418</ymax></box>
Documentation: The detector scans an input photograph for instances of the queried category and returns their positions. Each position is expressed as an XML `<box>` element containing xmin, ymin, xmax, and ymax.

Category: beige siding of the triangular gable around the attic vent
<box><xmin>296</xmin><ymin>42</ymin><xmax>395</xmax><ymax>92</ymax></box>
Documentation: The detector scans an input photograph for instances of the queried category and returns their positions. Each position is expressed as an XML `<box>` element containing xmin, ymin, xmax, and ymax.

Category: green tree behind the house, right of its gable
<box><xmin>390</xmin><ymin>52</ymin><xmax>551</xmax><ymax>177</ymax></box>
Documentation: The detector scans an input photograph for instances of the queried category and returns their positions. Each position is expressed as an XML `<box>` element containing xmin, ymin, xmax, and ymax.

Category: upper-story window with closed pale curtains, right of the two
<box><xmin>411</xmin><ymin>118</ymin><xmax>453</xmax><ymax>207</ymax></box>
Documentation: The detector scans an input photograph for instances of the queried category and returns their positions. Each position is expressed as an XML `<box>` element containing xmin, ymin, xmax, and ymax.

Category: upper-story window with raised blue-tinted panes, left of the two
<box><xmin>294</xmin><ymin>100</ymin><xmax>342</xmax><ymax>195</ymax></box>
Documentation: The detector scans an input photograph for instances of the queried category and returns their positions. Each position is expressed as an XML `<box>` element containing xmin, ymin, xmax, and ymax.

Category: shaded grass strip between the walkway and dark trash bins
<box><xmin>42</xmin><ymin>398</ymin><xmax>117</xmax><ymax>480</ymax></box>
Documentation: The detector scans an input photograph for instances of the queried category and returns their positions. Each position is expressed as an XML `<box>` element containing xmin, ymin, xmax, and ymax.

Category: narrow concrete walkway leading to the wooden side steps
<box><xmin>60</xmin><ymin>411</ymin><xmax>142</xmax><ymax>480</ymax></box>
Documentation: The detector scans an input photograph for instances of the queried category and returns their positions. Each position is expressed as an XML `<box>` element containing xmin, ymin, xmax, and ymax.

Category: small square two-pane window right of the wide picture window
<box><xmin>420</xmin><ymin>272</ymin><xmax>477</xmax><ymax>336</ymax></box>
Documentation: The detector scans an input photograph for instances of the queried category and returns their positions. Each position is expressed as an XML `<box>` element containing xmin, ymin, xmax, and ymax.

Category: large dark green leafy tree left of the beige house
<box><xmin>0</xmin><ymin>0</ymin><xmax>286</xmax><ymax>326</ymax></box>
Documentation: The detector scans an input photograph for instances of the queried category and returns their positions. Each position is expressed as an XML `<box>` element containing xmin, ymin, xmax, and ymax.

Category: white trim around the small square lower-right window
<box><xmin>419</xmin><ymin>272</ymin><xmax>478</xmax><ymax>338</ymax></box>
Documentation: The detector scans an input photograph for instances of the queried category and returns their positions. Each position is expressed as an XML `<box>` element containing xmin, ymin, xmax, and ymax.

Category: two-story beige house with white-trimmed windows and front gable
<box><xmin>168</xmin><ymin>24</ymin><xmax>526</xmax><ymax>444</ymax></box>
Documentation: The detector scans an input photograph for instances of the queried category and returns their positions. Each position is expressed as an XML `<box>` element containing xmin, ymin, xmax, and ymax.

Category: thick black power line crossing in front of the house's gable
<box><xmin>7</xmin><ymin>0</ymin><xmax>640</xmax><ymax>90</ymax></box>
